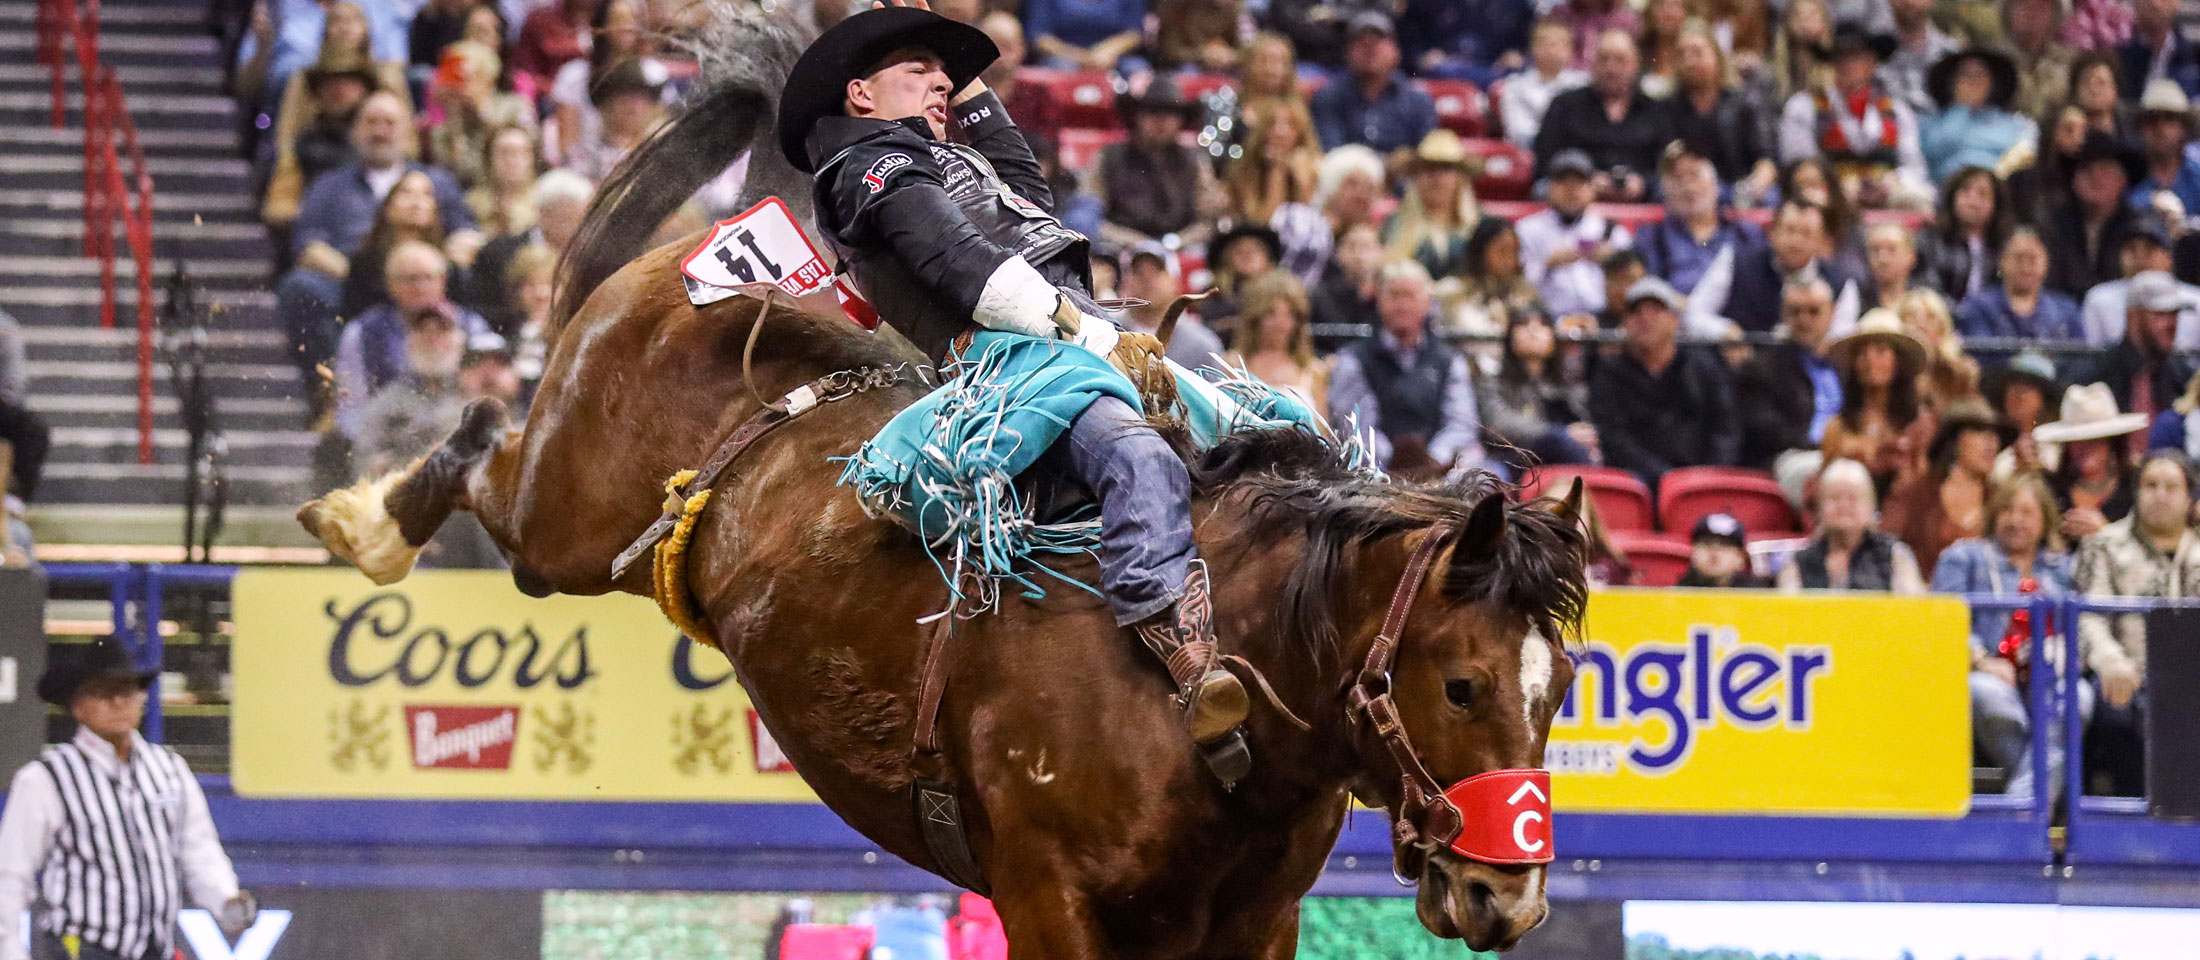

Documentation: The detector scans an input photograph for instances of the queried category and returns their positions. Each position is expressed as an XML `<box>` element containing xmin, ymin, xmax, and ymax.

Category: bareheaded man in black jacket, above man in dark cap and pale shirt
<box><xmin>1536</xmin><ymin>31</ymin><xmax>1672</xmax><ymax>203</ymax></box>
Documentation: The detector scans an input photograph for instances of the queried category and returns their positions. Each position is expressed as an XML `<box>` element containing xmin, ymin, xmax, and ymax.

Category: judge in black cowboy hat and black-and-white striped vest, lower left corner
<box><xmin>0</xmin><ymin>639</ymin><xmax>257</xmax><ymax>960</ymax></box>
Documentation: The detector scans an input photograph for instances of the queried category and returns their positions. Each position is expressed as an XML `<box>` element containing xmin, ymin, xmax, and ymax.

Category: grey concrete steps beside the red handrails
<box><xmin>0</xmin><ymin>0</ymin><xmax>315</xmax><ymax>510</ymax></box>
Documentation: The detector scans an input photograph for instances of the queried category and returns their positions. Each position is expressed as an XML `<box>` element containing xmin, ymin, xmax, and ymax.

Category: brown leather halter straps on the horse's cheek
<box><xmin>1344</xmin><ymin>524</ymin><xmax>1465</xmax><ymax>883</ymax></box>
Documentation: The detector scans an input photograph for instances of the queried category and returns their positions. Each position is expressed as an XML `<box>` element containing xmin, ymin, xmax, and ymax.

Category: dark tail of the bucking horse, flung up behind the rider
<box><xmin>548</xmin><ymin>2</ymin><xmax>810</xmax><ymax>343</ymax></box>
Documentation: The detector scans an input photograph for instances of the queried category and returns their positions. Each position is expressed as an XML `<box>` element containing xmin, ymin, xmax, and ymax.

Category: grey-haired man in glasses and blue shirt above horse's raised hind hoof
<box><xmin>334</xmin><ymin>240</ymin><xmax>488</xmax><ymax>440</ymax></box>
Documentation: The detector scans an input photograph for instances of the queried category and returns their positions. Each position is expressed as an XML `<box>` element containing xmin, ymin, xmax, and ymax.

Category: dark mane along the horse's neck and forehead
<box><xmin>1192</xmin><ymin>427</ymin><xmax>1588</xmax><ymax>654</ymax></box>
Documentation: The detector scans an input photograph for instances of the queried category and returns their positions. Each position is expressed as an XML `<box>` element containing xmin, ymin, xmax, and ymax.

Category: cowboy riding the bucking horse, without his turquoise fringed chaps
<box><xmin>779</xmin><ymin>0</ymin><xmax>1252</xmax><ymax>784</ymax></box>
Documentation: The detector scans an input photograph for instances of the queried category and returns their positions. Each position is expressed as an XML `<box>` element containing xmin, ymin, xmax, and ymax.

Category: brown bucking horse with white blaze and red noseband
<box><xmin>299</xmin><ymin>13</ymin><xmax>1586</xmax><ymax>960</ymax></box>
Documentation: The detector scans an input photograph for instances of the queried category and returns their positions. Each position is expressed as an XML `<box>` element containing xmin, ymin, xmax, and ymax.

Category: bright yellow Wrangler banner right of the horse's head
<box><xmin>1544</xmin><ymin>590</ymin><xmax>1971</xmax><ymax>817</ymax></box>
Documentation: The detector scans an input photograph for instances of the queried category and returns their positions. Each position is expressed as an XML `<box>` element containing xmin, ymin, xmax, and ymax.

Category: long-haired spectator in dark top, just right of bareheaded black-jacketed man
<box><xmin>1668</xmin><ymin>20</ymin><xmax>1780</xmax><ymax>205</ymax></box>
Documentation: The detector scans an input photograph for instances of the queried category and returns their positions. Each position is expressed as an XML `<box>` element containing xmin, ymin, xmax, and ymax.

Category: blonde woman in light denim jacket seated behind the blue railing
<box><xmin>1932</xmin><ymin>471</ymin><xmax>2092</xmax><ymax>797</ymax></box>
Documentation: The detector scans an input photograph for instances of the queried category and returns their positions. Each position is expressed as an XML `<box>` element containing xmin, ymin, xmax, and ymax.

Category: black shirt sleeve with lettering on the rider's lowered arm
<box><xmin>825</xmin><ymin>134</ymin><xmax>1016</xmax><ymax>315</ymax></box>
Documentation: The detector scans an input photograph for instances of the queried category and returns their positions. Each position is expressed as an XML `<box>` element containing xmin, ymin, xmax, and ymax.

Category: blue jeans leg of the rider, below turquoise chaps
<box><xmin>1041</xmin><ymin>396</ymin><xmax>1199</xmax><ymax>625</ymax></box>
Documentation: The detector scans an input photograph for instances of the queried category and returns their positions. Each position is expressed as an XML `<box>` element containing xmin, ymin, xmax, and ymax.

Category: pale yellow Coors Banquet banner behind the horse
<box><xmin>231</xmin><ymin>568</ymin><xmax>814</xmax><ymax>801</ymax></box>
